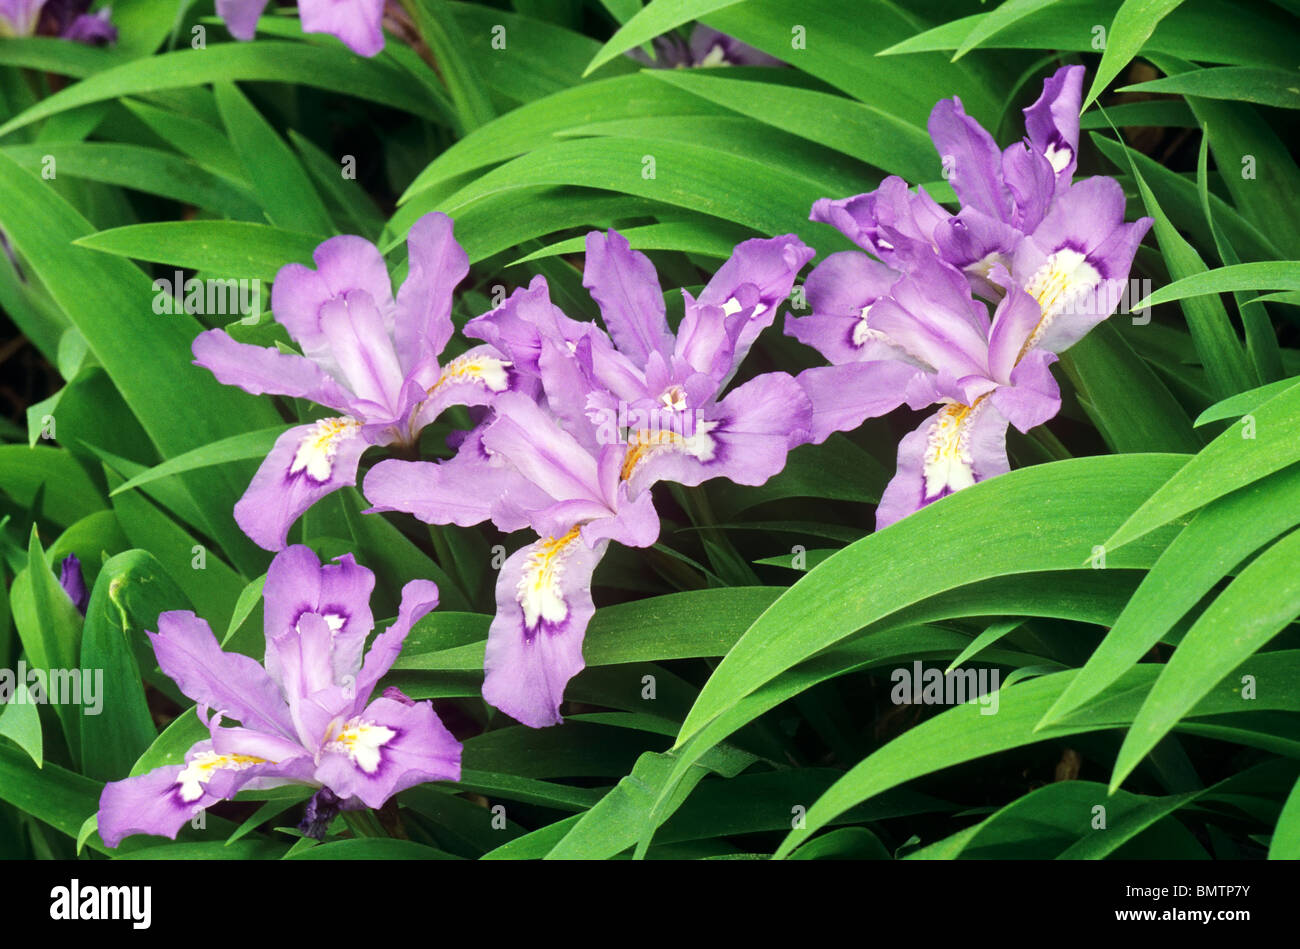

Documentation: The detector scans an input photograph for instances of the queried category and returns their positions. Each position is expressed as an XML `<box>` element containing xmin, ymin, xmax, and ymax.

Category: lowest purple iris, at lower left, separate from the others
<box><xmin>99</xmin><ymin>546</ymin><xmax>460</xmax><ymax>848</ymax></box>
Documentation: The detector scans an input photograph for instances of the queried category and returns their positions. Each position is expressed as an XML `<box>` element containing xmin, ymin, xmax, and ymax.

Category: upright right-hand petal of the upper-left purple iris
<box><xmin>393</xmin><ymin>212</ymin><xmax>469</xmax><ymax>374</ymax></box>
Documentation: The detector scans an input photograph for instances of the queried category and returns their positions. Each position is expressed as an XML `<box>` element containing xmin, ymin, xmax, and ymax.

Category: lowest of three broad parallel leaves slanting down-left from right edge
<box><xmin>1110</xmin><ymin>533</ymin><xmax>1300</xmax><ymax>789</ymax></box>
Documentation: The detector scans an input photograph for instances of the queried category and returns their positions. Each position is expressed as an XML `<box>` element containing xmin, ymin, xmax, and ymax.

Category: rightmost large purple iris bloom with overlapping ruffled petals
<box><xmin>785</xmin><ymin>66</ymin><xmax>1152</xmax><ymax>528</ymax></box>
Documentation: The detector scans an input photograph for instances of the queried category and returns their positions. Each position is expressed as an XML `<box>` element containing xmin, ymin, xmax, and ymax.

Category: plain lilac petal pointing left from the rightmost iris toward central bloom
<box><xmin>796</xmin><ymin>360</ymin><xmax>920</xmax><ymax>445</ymax></box>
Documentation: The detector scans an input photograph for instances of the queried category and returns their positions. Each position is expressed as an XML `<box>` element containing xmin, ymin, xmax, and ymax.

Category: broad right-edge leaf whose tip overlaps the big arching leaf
<box><xmin>1105</xmin><ymin>382</ymin><xmax>1300</xmax><ymax>551</ymax></box>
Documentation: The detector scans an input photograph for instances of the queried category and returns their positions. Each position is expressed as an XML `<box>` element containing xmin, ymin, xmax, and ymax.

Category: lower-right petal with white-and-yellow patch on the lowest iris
<box><xmin>316</xmin><ymin>698</ymin><xmax>462</xmax><ymax>807</ymax></box>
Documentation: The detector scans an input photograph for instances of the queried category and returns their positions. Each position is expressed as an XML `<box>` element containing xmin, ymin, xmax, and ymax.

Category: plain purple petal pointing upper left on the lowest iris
<box><xmin>147</xmin><ymin>610</ymin><xmax>294</xmax><ymax>736</ymax></box>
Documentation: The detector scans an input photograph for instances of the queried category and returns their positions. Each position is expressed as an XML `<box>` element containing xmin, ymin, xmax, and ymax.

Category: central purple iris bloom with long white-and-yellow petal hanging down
<box><xmin>365</xmin><ymin>231</ymin><xmax>813</xmax><ymax>727</ymax></box>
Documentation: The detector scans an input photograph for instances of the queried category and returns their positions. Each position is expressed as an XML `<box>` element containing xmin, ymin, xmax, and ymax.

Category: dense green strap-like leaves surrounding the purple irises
<box><xmin>0</xmin><ymin>0</ymin><xmax>1300</xmax><ymax>859</ymax></box>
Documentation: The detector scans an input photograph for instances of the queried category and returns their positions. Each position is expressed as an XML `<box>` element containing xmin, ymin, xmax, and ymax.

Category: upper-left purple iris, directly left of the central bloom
<box><xmin>194</xmin><ymin>206</ymin><xmax>512</xmax><ymax>550</ymax></box>
